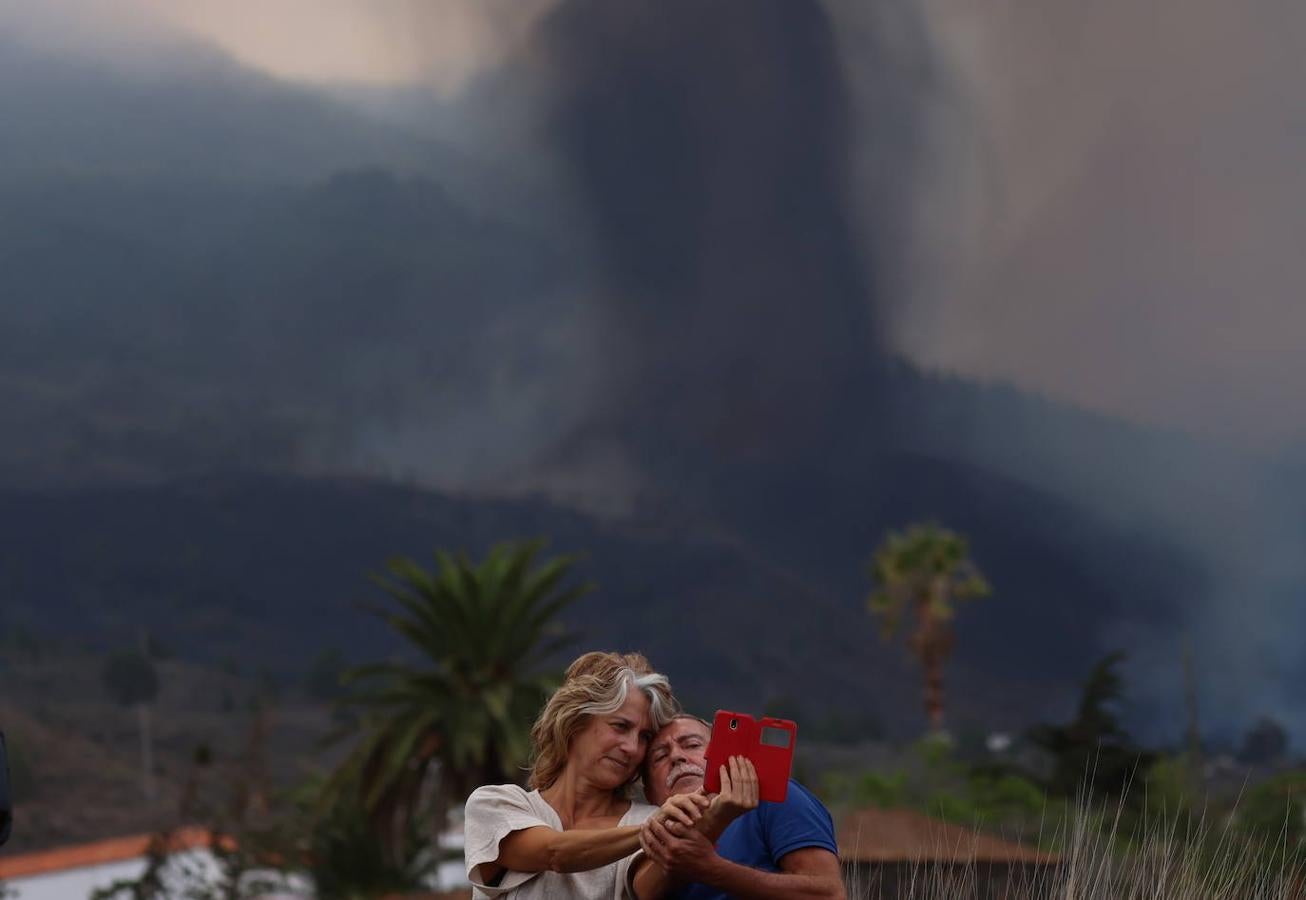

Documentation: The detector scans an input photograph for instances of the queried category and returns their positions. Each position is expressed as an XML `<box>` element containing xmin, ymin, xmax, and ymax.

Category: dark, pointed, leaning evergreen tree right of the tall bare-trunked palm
<box><xmin>1029</xmin><ymin>651</ymin><xmax>1156</xmax><ymax>797</ymax></box>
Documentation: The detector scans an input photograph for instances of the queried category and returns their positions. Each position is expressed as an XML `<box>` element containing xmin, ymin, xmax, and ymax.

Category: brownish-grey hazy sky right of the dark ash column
<box><xmin>900</xmin><ymin>0</ymin><xmax>1306</xmax><ymax>443</ymax></box>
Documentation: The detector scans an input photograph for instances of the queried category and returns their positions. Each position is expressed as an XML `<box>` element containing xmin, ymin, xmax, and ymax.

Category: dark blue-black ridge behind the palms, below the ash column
<box><xmin>0</xmin><ymin>460</ymin><xmax>1182</xmax><ymax>733</ymax></box>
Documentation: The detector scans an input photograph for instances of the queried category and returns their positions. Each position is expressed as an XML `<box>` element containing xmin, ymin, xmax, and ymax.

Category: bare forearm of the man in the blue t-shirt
<box><xmin>644</xmin><ymin>822</ymin><xmax>846</xmax><ymax>900</ymax></box>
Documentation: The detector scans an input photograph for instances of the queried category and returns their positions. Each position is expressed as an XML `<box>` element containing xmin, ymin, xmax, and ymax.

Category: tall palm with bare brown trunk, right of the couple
<box><xmin>867</xmin><ymin>525</ymin><xmax>991</xmax><ymax>733</ymax></box>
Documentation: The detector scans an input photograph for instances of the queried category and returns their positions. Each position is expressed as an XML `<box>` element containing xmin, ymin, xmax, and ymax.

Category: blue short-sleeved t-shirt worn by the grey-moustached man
<box><xmin>675</xmin><ymin>781</ymin><xmax>838</xmax><ymax>900</ymax></box>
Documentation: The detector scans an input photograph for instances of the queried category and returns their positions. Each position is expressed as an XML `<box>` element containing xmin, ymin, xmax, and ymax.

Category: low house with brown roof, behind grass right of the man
<box><xmin>838</xmin><ymin>809</ymin><xmax>1060</xmax><ymax>900</ymax></box>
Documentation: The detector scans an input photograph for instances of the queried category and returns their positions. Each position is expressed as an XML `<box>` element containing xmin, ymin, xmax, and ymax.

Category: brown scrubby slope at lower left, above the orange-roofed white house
<box><xmin>0</xmin><ymin>650</ymin><xmax>334</xmax><ymax>853</ymax></box>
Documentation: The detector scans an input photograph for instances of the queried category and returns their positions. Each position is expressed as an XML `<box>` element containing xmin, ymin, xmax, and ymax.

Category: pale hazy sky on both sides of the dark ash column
<box><xmin>10</xmin><ymin>0</ymin><xmax>1306</xmax><ymax>445</ymax></box>
